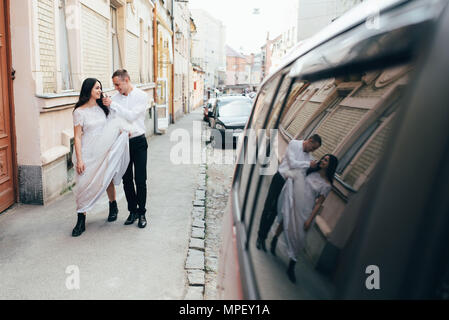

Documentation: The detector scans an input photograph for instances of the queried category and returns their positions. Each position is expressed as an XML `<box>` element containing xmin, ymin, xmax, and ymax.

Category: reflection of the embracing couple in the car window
<box><xmin>256</xmin><ymin>134</ymin><xmax>338</xmax><ymax>282</ymax></box>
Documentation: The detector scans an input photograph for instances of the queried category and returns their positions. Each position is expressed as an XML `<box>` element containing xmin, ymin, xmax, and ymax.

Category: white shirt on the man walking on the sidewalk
<box><xmin>110</xmin><ymin>87</ymin><xmax>148</xmax><ymax>138</ymax></box>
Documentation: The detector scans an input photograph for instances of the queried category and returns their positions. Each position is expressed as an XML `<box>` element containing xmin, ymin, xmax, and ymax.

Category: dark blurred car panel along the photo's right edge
<box><xmin>338</xmin><ymin>1</ymin><xmax>449</xmax><ymax>299</ymax></box>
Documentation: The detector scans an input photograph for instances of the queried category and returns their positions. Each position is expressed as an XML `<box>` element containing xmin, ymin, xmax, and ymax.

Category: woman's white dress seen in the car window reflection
<box><xmin>278</xmin><ymin>169</ymin><xmax>332</xmax><ymax>261</ymax></box>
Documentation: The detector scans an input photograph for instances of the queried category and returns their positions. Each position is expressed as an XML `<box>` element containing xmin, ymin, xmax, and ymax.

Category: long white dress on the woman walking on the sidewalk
<box><xmin>72</xmin><ymin>106</ymin><xmax>130</xmax><ymax>212</ymax></box>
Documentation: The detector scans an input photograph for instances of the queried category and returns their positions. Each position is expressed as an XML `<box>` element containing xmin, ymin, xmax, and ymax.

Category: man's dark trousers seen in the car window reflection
<box><xmin>258</xmin><ymin>171</ymin><xmax>285</xmax><ymax>240</ymax></box>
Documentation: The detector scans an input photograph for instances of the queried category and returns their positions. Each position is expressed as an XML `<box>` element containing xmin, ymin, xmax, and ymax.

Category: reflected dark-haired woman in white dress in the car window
<box><xmin>271</xmin><ymin>154</ymin><xmax>338</xmax><ymax>283</ymax></box>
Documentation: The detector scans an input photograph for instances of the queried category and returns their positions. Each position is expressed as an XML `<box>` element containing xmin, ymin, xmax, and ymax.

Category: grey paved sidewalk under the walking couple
<box><xmin>0</xmin><ymin>108</ymin><xmax>202</xmax><ymax>299</ymax></box>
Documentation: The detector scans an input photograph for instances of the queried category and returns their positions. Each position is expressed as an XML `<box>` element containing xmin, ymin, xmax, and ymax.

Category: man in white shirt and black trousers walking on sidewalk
<box><xmin>103</xmin><ymin>69</ymin><xmax>148</xmax><ymax>228</ymax></box>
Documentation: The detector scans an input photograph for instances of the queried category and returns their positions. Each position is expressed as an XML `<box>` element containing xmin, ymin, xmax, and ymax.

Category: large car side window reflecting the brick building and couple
<box><xmin>247</xmin><ymin>65</ymin><xmax>413</xmax><ymax>299</ymax></box>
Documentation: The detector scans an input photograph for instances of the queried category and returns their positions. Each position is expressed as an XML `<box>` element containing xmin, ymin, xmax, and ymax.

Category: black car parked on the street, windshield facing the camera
<box><xmin>210</xmin><ymin>97</ymin><xmax>252</xmax><ymax>148</ymax></box>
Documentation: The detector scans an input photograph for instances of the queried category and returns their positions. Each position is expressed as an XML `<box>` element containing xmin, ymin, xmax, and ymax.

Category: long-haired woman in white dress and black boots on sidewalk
<box><xmin>72</xmin><ymin>78</ymin><xmax>129</xmax><ymax>237</ymax></box>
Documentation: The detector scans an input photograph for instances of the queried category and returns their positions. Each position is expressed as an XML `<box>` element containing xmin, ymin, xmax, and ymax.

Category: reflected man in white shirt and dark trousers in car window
<box><xmin>256</xmin><ymin>134</ymin><xmax>321</xmax><ymax>251</ymax></box>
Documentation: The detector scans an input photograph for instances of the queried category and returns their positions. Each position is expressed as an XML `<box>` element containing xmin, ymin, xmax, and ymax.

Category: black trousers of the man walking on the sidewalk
<box><xmin>123</xmin><ymin>134</ymin><xmax>148</xmax><ymax>214</ymax></box>
